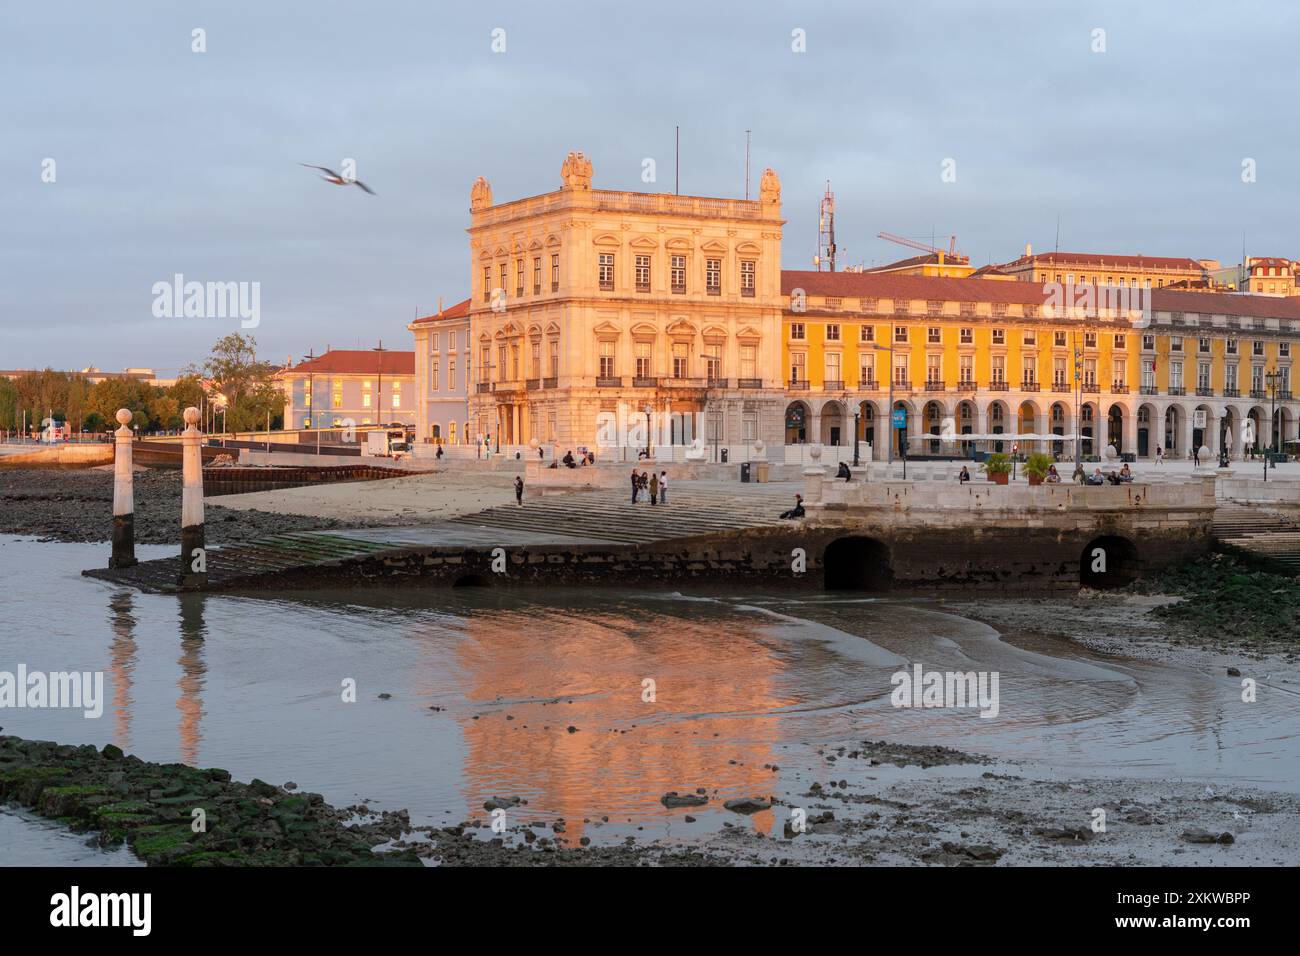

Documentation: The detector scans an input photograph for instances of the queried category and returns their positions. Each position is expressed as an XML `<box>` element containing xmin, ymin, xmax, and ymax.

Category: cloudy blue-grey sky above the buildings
<box><xmin>0</xmin><ymin>0</ymin><xmax>1300</xmax><ymax>376</ymax></box>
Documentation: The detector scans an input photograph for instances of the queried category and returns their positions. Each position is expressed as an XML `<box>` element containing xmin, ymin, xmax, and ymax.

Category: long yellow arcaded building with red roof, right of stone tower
<box><xmin>783</xmin><ymin>272</ymin><xmax>1300</xmax><ymax>459</ymax></box>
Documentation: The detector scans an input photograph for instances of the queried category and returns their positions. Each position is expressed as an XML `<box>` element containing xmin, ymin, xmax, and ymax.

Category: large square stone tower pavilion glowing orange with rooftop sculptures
<box><xmin>469</xmin><ymin>153</ymin><xmax>783</xmax><ymax>457</ymax></box>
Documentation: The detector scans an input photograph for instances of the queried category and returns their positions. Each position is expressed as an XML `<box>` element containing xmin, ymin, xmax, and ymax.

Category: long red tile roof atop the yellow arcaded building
<box><xmin>781</xmin><ymin>269</ymin><xmax>1300</xmax><ymax>319</ymax></box>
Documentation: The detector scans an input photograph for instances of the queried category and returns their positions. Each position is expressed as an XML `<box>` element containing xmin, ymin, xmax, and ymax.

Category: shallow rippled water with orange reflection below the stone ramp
<box><xmin>0</xmin><ymin>537</ymin><xmax>1300</xmax><ymax>858</ymax></box>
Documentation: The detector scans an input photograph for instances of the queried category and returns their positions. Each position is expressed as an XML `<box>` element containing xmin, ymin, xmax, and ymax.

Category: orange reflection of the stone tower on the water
<box><xmin>441</xmin><ymin>606</ymin><xmax>794</xmax><ymax>844</ymax></box>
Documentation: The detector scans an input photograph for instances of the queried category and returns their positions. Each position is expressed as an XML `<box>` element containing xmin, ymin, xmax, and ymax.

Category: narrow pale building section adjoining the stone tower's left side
<box><xmin>407</xmin><ymin>299</ymin><xmax>473</xmax><ymax>445</ymax></box>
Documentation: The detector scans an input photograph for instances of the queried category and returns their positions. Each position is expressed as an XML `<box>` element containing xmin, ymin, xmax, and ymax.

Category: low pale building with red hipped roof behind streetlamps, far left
<box><xmin>276</xmin><ymin>349</ymin><xmax>416</xmax><ymax>428</ymax></box>
